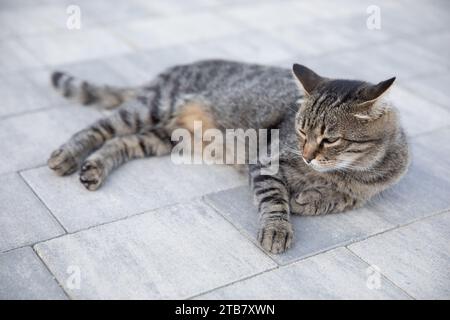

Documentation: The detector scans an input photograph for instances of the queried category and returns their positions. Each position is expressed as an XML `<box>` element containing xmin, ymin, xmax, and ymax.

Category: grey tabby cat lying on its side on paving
<box><xmin>48</xmin><ymin>60</ymin><xmax>409</xmax><ymax>253</ymax></box>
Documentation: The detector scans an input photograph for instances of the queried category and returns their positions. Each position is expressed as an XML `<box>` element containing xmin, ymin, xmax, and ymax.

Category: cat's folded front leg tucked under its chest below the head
<box><xmin>291</xmin><ymin>185</ymin><xmax>364</xmax><ymax>216</ymax></box>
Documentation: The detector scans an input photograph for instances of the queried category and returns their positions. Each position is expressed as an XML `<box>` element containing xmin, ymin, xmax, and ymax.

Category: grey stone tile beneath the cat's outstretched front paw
<box><xmin>205</xmin><ymin>187</ymin><xmax>392</xmax><ymax>264</ymax></box>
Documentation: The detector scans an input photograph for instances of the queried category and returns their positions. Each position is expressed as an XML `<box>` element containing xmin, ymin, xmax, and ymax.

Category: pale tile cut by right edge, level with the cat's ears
<box><xmin>405</xmin><ymin>74</ymin><xmax>450</xmax><ymax>110</ymax></box>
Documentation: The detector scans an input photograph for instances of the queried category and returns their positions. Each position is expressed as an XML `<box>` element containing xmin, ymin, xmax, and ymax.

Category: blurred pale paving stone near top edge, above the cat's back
<box><xmin>112</xmin><ymin>12</ymin><xmax>240</xmax><ymax>49</ymax></box>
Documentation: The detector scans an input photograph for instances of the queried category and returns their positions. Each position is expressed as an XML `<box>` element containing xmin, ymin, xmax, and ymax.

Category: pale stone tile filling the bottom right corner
<box><xmin>350</xmin><ymin>212</ymin><xmax>450</xmax><ymax>299</ymax></box>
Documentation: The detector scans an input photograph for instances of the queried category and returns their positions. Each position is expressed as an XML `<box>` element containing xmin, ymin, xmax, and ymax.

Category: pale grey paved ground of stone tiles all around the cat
<box><xmin>0</xmin><ymin>0</ymin><xmax>450</xmax><ymax>299</ymax></box>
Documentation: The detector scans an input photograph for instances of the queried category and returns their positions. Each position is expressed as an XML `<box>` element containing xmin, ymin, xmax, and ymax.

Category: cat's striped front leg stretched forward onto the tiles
<box><xmin>249</xmin><ymin>165</ymin><xmax>294</xmax><ymax>253</ymax></box>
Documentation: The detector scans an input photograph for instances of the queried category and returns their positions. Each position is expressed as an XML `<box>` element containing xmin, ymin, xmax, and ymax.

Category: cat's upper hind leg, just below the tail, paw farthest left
<box><xmin>47</xmin><ymin>101</ymin><xmax>150</xmax><ymax>175</ymax></box>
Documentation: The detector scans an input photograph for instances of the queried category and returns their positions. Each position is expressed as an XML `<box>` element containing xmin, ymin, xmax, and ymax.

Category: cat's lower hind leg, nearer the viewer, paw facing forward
<box><xmin>80</xmin><ymin>129</ymin><xmax>172</xmax><ymax>190</ymax></box>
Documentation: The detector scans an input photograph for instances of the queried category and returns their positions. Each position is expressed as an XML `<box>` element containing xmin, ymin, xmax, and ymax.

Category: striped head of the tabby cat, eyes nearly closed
<box><xmin>293</xmin><ymin>64</ymin><xmax>398</xmax><ymax>172</ymax></box>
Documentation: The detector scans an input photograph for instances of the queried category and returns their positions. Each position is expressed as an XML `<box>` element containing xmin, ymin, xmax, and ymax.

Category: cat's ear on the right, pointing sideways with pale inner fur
<box><xmin>354</xmin><ymin>77</ymin><xmax>395</xmax><ymax>121</ymax></box>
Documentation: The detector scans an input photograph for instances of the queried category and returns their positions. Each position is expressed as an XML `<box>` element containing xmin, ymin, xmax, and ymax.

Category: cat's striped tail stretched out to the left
<box><xmin>51</xmin><ymin>71</ymin><xmax>136</xmax><ymax>109</ymax></box>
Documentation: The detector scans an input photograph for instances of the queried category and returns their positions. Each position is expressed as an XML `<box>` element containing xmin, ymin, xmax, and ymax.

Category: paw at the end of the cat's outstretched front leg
<box><xmin>258</xmin><ymin>220</ymin><xmax>294</xmax><ymax>253</ymax></box>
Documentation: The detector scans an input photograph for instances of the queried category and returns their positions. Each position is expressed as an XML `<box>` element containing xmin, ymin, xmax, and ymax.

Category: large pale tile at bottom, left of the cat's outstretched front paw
<box><xmin>35</xmin><ymin>201</ymin><xmax>275</xmax><ymax>299</ymax></box>
